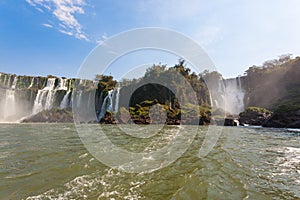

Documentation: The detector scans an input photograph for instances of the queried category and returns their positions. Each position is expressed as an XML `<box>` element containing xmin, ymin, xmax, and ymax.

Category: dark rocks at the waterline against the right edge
<box><xmin>263</xmin><ymin>110</ymin><xmax>300</xmax><ymax>128</ymax></box>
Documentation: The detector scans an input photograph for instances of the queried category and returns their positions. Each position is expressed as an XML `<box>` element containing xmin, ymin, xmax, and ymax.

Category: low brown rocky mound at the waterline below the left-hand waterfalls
<box><xmin>21</xmin><ymin>109</ymin><xmax>74</xmax><ymax>123</ymax></box>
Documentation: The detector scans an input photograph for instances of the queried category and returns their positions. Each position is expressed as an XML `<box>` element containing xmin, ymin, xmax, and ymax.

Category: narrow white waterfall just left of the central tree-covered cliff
<box><xmin>98</xmin><ymin>88</ymin><xmax>120</xmax><ymax>121</ymax></box>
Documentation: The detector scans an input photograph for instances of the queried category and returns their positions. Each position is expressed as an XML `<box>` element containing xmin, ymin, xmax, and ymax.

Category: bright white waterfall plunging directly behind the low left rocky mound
<box><xmin>32</xmin><ymin>78</ymin><xmax>56</xmax><ymax>114</ymax></box>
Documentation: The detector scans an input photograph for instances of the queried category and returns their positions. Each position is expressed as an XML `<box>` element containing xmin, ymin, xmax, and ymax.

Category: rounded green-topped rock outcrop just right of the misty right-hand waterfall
<box><xmin>239</xmin><ymin>108</ymin><xmax>272</xmax><ymax>126</ymax></box>
